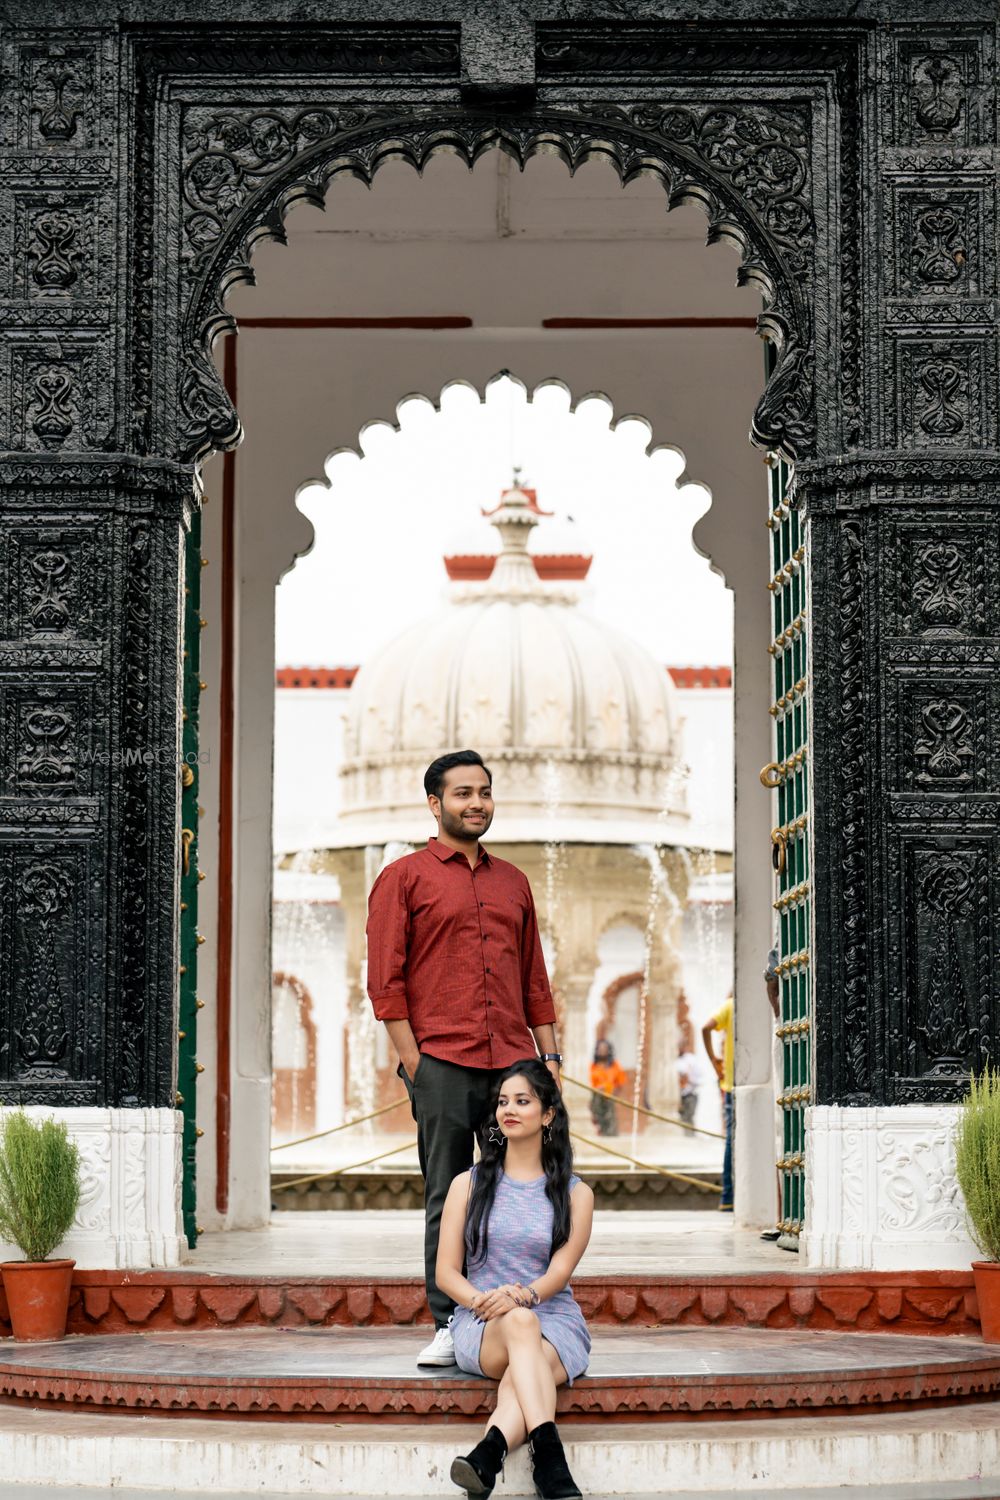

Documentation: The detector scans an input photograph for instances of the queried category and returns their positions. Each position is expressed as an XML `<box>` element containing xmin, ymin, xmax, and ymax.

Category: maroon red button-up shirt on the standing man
<box><xmin>367</xmin><ymin>839</ymin><xmax>556</xmax><ymax>1068</ymax></box>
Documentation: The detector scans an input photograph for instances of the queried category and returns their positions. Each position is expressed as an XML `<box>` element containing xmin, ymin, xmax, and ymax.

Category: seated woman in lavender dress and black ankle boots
<box><xmin>436</xmin><ymin>1059</ymin><xmax>594</xmax><ymax>1500</ymax></box>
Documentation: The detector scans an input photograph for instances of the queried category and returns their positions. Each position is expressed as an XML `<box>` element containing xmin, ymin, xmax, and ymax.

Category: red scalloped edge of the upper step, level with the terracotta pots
<box><xmin>0</xmin><ymin>1269</ymin><xmax>979</xmax><ymax>1334</ymax></box>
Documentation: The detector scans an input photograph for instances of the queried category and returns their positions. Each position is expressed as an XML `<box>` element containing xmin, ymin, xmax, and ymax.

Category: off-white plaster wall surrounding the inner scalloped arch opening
<box><xmin>201</xmin><ymin>156</ymin><xmax>772</xmax><ymax>1226</ymax></box>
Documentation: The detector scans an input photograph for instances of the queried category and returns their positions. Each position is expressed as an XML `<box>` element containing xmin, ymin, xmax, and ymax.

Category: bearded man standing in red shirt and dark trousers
<box><xmin>367</xmin><ymin>750</ymin><xmax>562</xmax><ymax>1365</ymax></box>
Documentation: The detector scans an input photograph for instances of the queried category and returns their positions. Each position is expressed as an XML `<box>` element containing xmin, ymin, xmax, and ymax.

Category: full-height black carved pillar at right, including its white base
<box><xmin>799</xmin><ymin>20</ymin><xmax>1000</xmax><ymax>1268</ymax></box>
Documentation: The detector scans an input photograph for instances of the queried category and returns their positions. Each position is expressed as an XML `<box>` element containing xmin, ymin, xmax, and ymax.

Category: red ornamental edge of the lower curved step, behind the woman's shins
<box><xmin>0</xmin><ymin>1359</ymin><xmax>1000</xmax><ymax>1421</ymax></box>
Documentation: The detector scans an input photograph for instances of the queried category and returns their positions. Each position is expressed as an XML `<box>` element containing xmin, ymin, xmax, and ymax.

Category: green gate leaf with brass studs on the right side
<box><xmin>760</xmin><ymin>455</ymin><xmax>813</xmax><ymax>1239</ymax></box>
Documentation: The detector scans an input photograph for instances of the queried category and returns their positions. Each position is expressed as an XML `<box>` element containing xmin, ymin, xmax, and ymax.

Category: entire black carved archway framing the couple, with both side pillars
<box><xmin>0</xmin><ymin>11</ymin><xmax>1000</xmax><ymax>1263</ymax></box>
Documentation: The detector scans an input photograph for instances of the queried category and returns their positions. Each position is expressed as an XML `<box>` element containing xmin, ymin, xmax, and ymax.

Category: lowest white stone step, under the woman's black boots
<box><xmin>0</xmin><ymin>1403</ymin><xmax>1000</xmax><ymax>1500</ymax></box>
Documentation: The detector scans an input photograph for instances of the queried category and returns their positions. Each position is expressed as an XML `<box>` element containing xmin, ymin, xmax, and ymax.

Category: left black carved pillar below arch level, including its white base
<box><xmin>0</xmin><ymin>453</ymin><xmax>193</xmax><ymax>1266</ymax></box>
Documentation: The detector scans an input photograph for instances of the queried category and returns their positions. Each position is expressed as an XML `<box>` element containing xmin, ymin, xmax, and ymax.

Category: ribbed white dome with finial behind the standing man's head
<box><xmin>339</xmin><ymin>491</ymin><xmax>685</xmax><ymax>845</ymax></box>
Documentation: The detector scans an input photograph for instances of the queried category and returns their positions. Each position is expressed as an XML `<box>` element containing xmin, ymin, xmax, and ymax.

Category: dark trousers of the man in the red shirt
<box><xmin>399</xmin><ymin>1052</ymin><xmax>502</xmax><ymax>1328</ymax></box>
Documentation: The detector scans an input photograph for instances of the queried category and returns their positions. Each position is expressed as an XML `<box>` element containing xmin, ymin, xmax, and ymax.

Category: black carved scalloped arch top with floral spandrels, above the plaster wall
<box><xmin>178</xmin><ymin>102</ymin><xmax>816</xmax><ymax>461</ymax></box>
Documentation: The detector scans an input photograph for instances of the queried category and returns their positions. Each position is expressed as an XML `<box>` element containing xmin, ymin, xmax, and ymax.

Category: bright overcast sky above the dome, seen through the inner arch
<box><xmin>276</xmin><ymin>380</ymin><xmax>733</xmax><ymax>666</ymax></box>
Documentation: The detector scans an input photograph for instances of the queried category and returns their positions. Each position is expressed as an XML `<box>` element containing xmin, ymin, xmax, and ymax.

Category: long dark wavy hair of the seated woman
<box><xmin>465</xmin><ymin>1058</ymin><xmax>573</xmax><ymax>1265</ymax></box>
